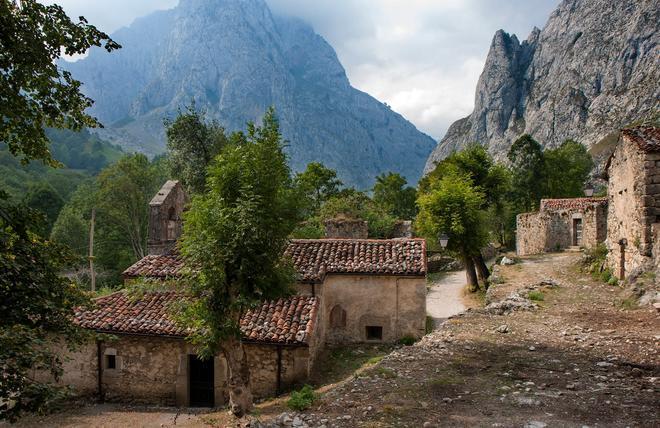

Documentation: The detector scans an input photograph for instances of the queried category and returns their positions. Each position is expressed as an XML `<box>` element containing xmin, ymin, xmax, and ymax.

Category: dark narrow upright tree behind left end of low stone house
<box><xmin>507</xmin><ymin>134</ymin><xmax>545</xmax><ymax>212</ymax></box>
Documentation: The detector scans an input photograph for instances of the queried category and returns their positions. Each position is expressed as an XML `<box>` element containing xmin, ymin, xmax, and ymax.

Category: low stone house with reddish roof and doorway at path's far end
<box><xmin>516</xmin><ymin>198</ymin><xmax>608</xmax><ymax>256</ymax></box>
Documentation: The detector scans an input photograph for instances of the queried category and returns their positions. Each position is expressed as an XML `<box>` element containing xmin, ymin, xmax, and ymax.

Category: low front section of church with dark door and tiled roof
<box><xmin>61</xmin><ymin>290</ymin><xmax>322</xmax><ymax>407</ymax></box>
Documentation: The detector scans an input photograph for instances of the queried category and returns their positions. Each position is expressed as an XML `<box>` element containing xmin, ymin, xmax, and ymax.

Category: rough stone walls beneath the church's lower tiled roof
<box><xmin>54</xmin><ymin>335</ymin><xmax>319</xmax><ymax>406</ymax></box>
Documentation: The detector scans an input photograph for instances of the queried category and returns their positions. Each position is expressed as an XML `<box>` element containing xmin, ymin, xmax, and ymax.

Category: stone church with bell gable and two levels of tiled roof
<box><xmin>63</xmin><ymin>181</ymin><xmax>426</xmax><ymax>406</ymax></box>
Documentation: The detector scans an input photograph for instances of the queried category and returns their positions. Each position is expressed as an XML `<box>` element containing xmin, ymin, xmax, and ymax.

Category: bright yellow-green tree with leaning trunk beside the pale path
<box><xmin>416</xmin><ymin>171</ymin><xmax>488</xmax><ymax>291</ymax></box>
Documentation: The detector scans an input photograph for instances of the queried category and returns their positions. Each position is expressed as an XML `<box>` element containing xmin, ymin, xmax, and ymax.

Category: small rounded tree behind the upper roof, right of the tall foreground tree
<box><xmin>295</xmin><ymin>162</ymin><xmax>343</xmax><ymax>213</ymax></box>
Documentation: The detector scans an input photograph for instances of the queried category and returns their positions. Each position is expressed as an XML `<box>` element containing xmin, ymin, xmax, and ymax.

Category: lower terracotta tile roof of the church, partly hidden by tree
<box><xmin>75</xmin><ymin>291</ymin><xmax>319</xmax><ymax>345</ymax></box>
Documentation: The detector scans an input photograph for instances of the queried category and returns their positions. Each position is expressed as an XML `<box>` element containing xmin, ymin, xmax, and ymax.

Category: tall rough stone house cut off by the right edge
<box><xmin>606</xmin><ymin>126</ymin><xmax>660</xmax><ymax>279</ymax></box>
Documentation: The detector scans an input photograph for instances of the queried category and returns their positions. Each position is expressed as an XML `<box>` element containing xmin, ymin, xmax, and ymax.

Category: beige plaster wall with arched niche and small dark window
<box><xmin>321</xmin><ymin>275</ymin><xmax>426</xmax><ymax>344</ymax></box>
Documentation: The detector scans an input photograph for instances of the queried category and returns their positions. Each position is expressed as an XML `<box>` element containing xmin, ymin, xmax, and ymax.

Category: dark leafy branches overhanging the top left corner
<box><xmin>0</xmin><ymin>0</ymin><xmax>121</xmax><ymax>165</ymax></box>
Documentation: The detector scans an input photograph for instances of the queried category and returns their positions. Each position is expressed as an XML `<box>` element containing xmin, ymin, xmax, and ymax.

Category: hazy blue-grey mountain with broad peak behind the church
<box><xmin>63</xmin><ymin>0</ymin><xmax>436</xmax><ymax>188</ymax></box>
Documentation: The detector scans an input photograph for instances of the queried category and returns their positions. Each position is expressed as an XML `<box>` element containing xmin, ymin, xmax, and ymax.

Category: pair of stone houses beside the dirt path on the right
<box><xmin>516</xmin><ymin>126</ymin><xmax>660</xmax><ymax>279</ymax></box>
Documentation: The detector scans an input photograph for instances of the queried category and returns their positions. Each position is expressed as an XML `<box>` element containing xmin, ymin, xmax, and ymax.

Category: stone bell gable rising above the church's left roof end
<box><xmin>147</xmin><ymin>180</ymin><xmax>189</xmax><ymax>255</ymax></box>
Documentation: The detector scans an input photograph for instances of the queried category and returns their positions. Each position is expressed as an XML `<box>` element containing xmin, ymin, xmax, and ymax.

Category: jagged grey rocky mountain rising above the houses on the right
<box><xmin>425</xmin><ymin>0</ymin><xmax>660</xmax><ymax>172</ymax></box>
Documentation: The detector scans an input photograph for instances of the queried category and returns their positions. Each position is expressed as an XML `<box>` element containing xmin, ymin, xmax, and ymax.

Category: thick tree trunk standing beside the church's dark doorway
<box><xmin>222</xmin><ymin>337</ymin><xmax>253</xmax><ymax>418</ymax></box>
